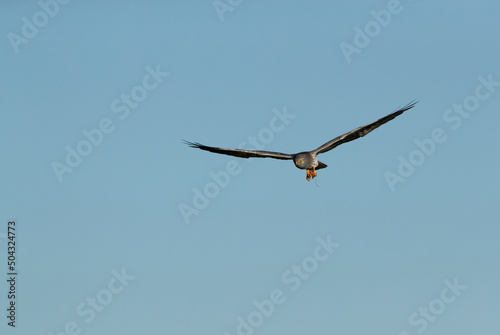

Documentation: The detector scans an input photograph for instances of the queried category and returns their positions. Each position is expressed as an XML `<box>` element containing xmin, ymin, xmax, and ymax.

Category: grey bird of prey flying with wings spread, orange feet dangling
<box><xmin>183</xmin><ymin>101</ymin><xmax>417</xmax><ymax>181</ymax></box>
